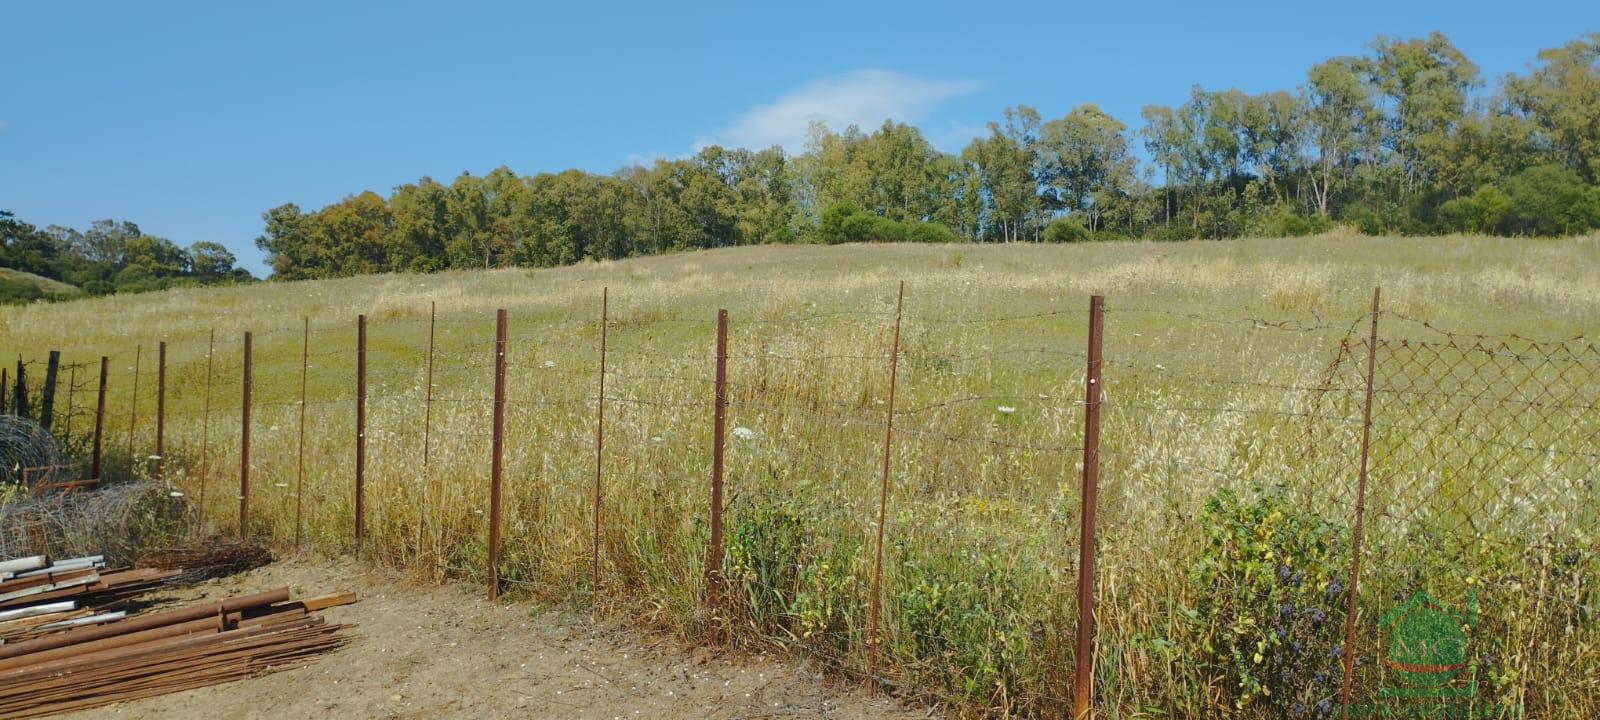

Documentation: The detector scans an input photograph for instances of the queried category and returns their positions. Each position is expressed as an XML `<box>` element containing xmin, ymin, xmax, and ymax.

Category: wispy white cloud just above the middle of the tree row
<box><xmin>694</xmin><ymin>69</ymin><xmax>978</xmax><ymax>152</ymax></box>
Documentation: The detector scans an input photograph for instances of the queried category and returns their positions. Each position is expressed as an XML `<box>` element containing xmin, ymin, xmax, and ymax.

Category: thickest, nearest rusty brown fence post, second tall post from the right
<box><xmin>1072</xmin><ymin>294</ymin><xmax>1106</xmax><ymax>718</ymax></box>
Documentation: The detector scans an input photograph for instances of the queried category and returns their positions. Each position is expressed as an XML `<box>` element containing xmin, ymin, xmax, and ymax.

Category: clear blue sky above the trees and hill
<box><xmin>0</xmin><ymin>0</ymin><xmax>1600</xmax><ymax>275</ymax></box>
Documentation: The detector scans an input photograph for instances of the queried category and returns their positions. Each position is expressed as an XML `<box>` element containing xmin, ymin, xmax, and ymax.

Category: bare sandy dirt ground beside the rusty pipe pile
<box><xmin>64</xmin><ymin>562</ymin><xmax>934</xmax><ymax>720</ymax></box>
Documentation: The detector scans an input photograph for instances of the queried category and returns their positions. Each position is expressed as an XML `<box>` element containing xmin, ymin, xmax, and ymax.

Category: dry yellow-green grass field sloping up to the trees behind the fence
<box><xmin>0</xmin><ymin>235</ymin><xmax>1600</xmax><ymax>718</ymax></box>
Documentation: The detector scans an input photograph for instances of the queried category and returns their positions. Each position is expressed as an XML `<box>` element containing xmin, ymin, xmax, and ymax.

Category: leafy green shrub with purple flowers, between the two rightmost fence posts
<box><xmin>1189</xmin><ymin>490</ymin><xmax>1349</xmax><ymax>718</ymax></box>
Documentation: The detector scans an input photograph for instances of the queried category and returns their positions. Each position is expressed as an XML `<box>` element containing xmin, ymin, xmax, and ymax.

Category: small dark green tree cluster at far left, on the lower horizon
<box><xmin>0</xmin><ymin>210</ymin><xmax>254</xmax><ymax>302</ymax></box>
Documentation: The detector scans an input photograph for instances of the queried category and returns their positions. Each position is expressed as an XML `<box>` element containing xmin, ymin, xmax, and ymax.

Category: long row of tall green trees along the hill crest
<box><xmin>258</xmin><ymin>34</ymin><xmax>1600</xmax><ymax>278</ymax></box>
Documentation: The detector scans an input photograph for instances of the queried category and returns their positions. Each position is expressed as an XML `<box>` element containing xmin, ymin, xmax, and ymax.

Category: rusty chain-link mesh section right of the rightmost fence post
<box><xmin>1352</xmin><ymin>315</ymin><xmax>1600</xmax><ymax>717</ymax></box>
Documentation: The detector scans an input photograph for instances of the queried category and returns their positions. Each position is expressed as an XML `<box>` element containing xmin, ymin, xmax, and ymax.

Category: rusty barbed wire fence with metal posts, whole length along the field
<box><xmin>8</xmin><ymin>284</ymin><xmax>1600</xmax><ymax>717</ymax></box>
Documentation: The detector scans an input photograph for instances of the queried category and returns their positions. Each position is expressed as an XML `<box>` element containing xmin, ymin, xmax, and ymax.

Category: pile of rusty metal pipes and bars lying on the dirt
<box><xmin>0</xmin><ymin>557</ymin><xmax>355</xmax><ymax>718</ymax></box>
